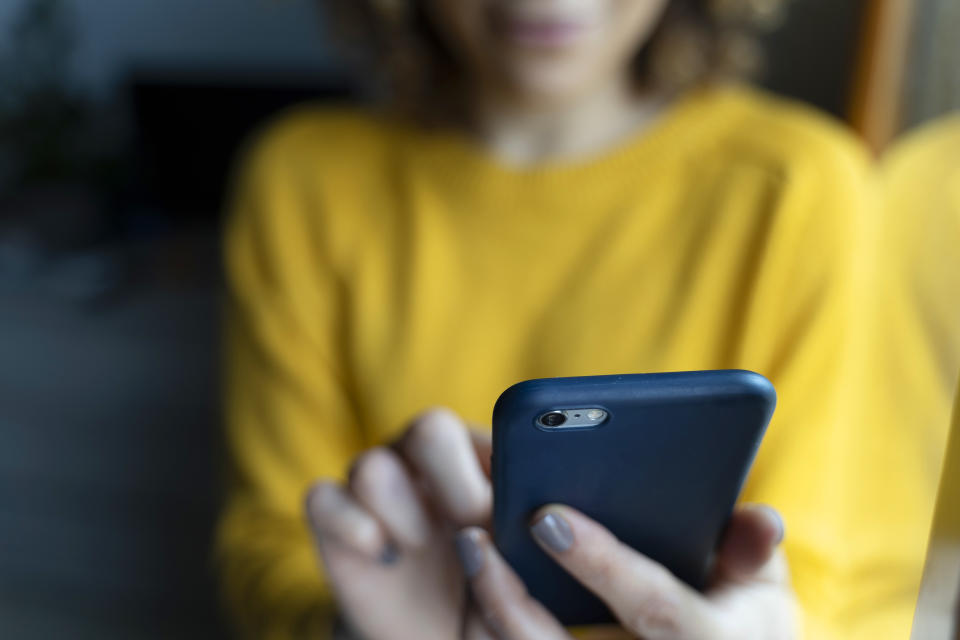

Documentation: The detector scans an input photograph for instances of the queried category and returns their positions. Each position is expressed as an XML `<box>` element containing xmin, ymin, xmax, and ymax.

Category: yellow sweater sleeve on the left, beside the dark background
<box><xmin>216</xmin><ymin>121</ymin><xmax>363</xmax><ymax>639</ymax></box>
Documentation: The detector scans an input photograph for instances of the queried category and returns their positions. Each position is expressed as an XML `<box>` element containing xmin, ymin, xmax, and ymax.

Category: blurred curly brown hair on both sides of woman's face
<box><xmin>320</xmin><ymin>0</ymin><xmax>789</xmax><ymax>119</ymax></box>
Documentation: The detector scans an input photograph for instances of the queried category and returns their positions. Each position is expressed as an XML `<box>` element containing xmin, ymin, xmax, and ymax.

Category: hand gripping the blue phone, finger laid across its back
<box><xmin>457</xmin><ymin>505</ymin><xmax>796</xmax><ymax>640</ymax></box>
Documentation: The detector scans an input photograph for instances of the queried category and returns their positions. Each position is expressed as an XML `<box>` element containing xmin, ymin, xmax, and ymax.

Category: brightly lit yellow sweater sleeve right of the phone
<box><xmin>742</xmin><ymin>127</ymin><xmax>935</xmax><ymax>640</ymax></box>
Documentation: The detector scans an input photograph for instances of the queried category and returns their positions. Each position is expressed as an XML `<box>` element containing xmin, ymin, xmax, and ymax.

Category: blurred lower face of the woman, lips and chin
<box><xmin>427</xmin><ymin>0</ymin><xmax>669</xmax><ymax>106</ymax></box>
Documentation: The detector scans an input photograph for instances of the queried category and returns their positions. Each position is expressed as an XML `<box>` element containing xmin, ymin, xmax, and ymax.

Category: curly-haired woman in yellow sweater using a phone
<box><xmin>219</xmin><ymin>0</ymin><xmax>932</xmax><ymax>640</ymax></box>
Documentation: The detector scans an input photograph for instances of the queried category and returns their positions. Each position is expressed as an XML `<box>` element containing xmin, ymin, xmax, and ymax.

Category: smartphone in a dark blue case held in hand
<box><xmin>492</xmin><ymin>370</ymin><xmax>776</xmax><ymax>626</ymax></box>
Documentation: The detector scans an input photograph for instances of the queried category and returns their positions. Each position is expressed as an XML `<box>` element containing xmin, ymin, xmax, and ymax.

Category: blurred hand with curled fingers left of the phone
<box><xmin>306</xmin><ymin>409</ymin><xmax>492</xmax><ymax>640</ymax></box>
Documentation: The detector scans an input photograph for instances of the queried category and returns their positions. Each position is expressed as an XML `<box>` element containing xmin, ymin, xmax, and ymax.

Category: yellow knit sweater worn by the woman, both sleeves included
<box><xmin>218</xmin><ymin>88</ymin><xmax>933</xmax><ymax>640</ymax></box>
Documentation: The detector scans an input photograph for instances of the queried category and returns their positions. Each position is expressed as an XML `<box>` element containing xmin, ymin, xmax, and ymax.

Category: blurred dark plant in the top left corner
<box><xmin>0</xmin><ymin>0</ymin><xmax>110</xmax><ymax>195</ymax></box>
